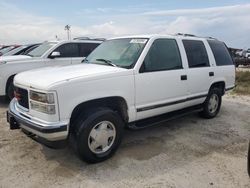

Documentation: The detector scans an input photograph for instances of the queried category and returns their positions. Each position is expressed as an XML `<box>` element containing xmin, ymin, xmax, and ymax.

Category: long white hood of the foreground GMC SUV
<box><xmin>14</xmin><ymin>63</ymin><xmax>130</xmax><ymax>90</ymax></box>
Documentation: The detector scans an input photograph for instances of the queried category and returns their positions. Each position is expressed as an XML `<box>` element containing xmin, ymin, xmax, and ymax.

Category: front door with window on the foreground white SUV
<box><xmin>135</xmin><ymin>38</ymin><xmax>187</xmax><ymax>120</ymax></box>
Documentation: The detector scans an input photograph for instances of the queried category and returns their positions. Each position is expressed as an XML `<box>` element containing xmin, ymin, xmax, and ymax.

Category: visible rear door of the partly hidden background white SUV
<box><xmin>72</xmin><ymin>43</ymin><xmax>99</xmax><ymax>64</ymax></box>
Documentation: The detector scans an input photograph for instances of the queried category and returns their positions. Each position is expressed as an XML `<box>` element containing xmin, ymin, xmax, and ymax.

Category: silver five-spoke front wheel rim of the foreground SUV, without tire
<box><xmin>88</xmin><ymin>121</ymin><xmax>116</xmax><ymax>154</ymax></box>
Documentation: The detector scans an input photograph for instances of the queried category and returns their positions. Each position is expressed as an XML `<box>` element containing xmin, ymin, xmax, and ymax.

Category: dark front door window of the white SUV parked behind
<box><xmin>54</xmin><ymin>43</ymin><xmax>80</xmax><ymax>57</ymax></box>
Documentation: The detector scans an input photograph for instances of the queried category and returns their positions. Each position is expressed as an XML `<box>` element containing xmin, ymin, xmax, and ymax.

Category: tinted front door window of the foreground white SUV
<box><xmin>141</xmin><ymin>39</ymin><xmax>182</xmax><ymax>72</ymax></box>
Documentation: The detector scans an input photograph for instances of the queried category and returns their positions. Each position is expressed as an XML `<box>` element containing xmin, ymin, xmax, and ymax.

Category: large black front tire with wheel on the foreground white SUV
<box><xmin>72</xmin><ymin>108</ymin><xmax>124</xmax><ymax>163</ymax></box>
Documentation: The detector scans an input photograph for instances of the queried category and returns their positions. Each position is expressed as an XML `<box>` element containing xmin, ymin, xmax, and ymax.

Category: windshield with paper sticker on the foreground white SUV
<box><xmin>86</xmin><ymin>38</ymin><xmax>148</xmax><ymax>68</ymax></box>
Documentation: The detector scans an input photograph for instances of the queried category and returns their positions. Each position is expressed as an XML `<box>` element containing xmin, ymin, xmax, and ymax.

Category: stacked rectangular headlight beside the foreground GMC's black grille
<box><xmin>30</xmin><ymin>91</ymin><xmax>56</xmax><ymax>115</ymax></box>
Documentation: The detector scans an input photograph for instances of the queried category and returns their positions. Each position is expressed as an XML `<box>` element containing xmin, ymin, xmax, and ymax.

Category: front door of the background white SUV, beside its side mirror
<box><xmin>48</xmin><ymin>43</ymin><xmax>79</xmax><ymax>66</ymax></box>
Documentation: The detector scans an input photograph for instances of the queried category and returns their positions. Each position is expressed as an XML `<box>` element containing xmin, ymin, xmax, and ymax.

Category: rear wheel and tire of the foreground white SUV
<box><xmin>201</xmin><ymin>88</ymin><xmax>222</xmax><ymax>119</ymax></box>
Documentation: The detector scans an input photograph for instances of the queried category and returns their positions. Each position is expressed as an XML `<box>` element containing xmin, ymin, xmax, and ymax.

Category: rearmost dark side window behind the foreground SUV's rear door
<box><xmin>208</xmin><ymin>40</ymin><xmax>233</xmax><ymax>66</ymax></box>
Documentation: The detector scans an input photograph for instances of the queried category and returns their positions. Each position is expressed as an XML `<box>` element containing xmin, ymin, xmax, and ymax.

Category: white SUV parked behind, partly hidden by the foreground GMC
<box><xmin>0</xmin><ymin>39</ymin><xmax>102</xmax><ymax>99</ymax></box>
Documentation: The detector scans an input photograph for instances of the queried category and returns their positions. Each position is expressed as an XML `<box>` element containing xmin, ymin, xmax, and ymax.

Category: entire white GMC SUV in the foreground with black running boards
<box><xmin>7</xmin><ymin>35</ymin><xmax>235</xmax><ymax>163</ymax></box>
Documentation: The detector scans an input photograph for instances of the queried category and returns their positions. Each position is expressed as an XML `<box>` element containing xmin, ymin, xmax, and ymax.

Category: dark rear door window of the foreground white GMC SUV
<box><xmin>183</xmin><ymin>40</ymin><xmax>209</xmax><ymax>68</ymax></box>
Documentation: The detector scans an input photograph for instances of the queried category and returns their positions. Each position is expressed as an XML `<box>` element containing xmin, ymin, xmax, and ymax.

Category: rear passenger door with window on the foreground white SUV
<box><xmin>183</xmin><ymin>40</ymin><xmax>214</xmax><ymax>106</ymax></box>
